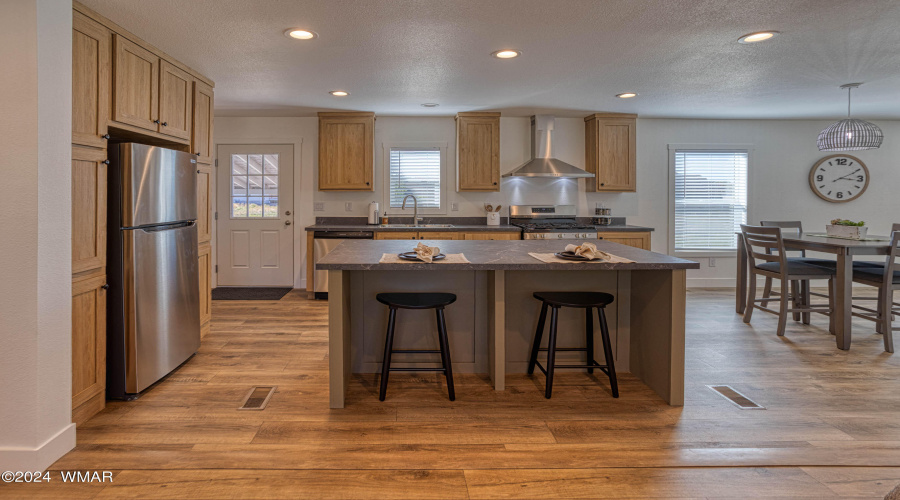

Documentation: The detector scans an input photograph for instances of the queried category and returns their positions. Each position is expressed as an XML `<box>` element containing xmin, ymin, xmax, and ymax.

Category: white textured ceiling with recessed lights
<box><xmin>81</xmin><ymin>0</ymin><xmax>900</xmax><ymax>118</ymax></box>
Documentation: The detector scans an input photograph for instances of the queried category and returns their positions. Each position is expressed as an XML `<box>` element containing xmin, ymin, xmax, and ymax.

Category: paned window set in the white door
<box><xmin>231</xmin><ymin>154</ymin><xmax>278</xmax><ymax>219</ymax></box>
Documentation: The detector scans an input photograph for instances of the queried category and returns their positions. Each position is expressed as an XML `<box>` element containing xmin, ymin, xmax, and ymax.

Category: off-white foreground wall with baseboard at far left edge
<box><xmin>0</xmin><ymin>0</ymin><xmax>75</xmax><ymax>470</ymax></box>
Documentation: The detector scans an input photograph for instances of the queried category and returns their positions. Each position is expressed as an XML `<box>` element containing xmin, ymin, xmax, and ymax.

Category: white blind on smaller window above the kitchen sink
<box><xmin>389</xmin><ymin>148</ymin><xmax>441</xmax><ymax>208</ymax></box>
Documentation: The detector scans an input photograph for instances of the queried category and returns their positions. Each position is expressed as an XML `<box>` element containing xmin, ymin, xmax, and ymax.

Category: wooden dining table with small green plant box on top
<box><xmin>735</xmin><ymin>233</ymin><xmax>891</xmax><ymax>350</ymax></box>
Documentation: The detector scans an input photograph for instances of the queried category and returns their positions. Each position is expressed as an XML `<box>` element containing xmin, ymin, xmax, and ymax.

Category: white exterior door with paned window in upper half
<box><xmin>216</xmin><ymin>144</ymin><xmax>294</xmax><ymax>286</ymax></box>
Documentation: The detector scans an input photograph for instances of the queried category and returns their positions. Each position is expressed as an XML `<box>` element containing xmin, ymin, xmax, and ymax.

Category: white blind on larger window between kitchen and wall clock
<box><xmin>675</xmin><ymin>150</ymin><xmax>749</xmax><ymax>250</ymax></box>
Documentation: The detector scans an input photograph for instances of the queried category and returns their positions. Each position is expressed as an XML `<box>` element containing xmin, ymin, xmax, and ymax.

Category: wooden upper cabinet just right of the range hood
<box><xmin>584</xmin><ymin>113</ymin><xmax>637</xmax><ymax>191</ymax></box>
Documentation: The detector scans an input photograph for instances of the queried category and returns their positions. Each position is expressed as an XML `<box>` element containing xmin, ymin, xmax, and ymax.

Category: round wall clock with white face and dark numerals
<box><xmin>809</xmin><ymin>155</ymin><xmax>869</xmax><ymax>203</ymax></box>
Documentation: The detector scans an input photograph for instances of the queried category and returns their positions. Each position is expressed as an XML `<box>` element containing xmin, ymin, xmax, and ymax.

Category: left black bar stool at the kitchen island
<box><xmin>375</xmin><ymin>293</ymin><xmax>456</xmax><ymax>401</ymax></box>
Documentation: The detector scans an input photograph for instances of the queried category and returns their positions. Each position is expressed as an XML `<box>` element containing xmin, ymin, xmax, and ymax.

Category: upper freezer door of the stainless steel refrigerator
<box><xmin>118</xmin><ymin>143</ymin><xmax>197</xmax><ymax>227</ymax></box>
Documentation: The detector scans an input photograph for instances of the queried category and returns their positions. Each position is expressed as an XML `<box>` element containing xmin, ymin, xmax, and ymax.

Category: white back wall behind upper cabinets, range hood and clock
<box><xmin>216</xmin><ymin>116</ymin><xmax>900</xmax><ymax>286</ymax></box>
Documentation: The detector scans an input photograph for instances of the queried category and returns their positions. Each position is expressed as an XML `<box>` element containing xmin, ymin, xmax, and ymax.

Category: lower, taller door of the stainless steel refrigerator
<box><xmin>123</xmin><ymin>222</ymin><xmax>200</xmax><ymax>393</ymax></box>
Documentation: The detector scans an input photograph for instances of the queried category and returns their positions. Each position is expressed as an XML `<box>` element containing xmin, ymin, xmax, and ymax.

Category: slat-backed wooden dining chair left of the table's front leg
<box><xmin>741</xmin><ymin>224</ymin><xmax>836</xmax><ymax>337</ymax></box>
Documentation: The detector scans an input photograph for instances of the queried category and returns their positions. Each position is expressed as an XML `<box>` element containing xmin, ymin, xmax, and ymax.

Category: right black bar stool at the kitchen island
<box><xmin>528</xmin><ymin>292</ymin><xmax>619</xmax><ymax>399</ymax></box>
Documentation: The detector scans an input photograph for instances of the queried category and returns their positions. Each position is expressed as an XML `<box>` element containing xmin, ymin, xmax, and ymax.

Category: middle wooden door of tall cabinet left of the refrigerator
<box><xmin>72</xmin><ymin>147</ymin><xmax>107</xmax><ymax>275</ymax></box>
